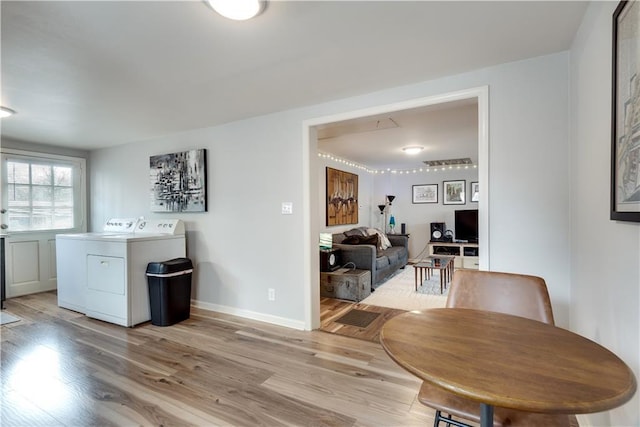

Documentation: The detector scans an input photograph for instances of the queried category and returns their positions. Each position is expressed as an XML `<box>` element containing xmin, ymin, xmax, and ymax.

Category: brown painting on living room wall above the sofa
<box><xmin>326</xmin><ymin>167</ymin><xmax>358</xmax><ymax>226</ymax></box>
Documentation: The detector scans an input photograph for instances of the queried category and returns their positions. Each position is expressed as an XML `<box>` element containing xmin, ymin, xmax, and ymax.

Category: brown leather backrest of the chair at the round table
<box><xmin>447</xmin><ymin>270</ymin><xmax>554</xmax><ymax>325</ymax></box>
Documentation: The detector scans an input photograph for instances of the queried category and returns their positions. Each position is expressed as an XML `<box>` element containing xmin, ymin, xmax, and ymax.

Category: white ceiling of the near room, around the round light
<box><xmin>0</xmin><ymin>0</ymin><xmax>586</xmax><ymax>160</ymax></box>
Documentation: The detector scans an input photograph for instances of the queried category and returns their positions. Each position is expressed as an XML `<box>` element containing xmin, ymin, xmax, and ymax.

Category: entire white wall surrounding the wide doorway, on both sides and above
<box><xmin>91</xmin><ymin>53</ymin><xmax>569</xmax><ymax>327</ymax></box>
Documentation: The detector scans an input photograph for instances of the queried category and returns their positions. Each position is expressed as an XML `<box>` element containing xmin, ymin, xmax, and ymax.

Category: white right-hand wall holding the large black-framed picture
<box><xmin>570</xmin><ymin>2</ymin><xmax>640</xmax><ymax>426</ymax></box>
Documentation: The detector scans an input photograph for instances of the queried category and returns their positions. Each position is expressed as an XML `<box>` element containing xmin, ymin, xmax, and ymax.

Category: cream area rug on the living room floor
<box><xmin>360</xmin><ymin>265</ymin><xmax>448</xmax><ymax>311</ymax></box>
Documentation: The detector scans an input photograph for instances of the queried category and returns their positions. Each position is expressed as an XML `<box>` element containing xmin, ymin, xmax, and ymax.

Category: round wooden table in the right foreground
<box><xmin>380</xmin><ymin>308</ymin><xmax>636</xmax><ymax>426</ymax></box>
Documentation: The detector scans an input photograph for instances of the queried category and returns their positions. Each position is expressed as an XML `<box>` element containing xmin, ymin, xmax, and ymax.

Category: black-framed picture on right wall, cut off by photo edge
<box><xmin>611</xmin><ymin>1</ymin><xmax>640</xmax><ymax>222</ymax></box>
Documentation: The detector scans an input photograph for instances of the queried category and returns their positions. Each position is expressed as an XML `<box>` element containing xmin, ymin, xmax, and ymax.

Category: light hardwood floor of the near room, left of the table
<box><xmin>0</xmin><ymin>292</ymin><xmax>433</xmax><ymax>426</ymax></box>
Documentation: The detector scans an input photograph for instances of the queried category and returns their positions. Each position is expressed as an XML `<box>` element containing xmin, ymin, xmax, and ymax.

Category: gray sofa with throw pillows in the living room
<box><xmin>332</xmin><ymin>227</ymin><xmax>409</xmax><ymax>289</ymax></box>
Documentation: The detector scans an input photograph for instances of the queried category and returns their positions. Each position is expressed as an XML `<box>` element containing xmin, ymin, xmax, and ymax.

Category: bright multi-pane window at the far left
<box><xmin>2</xmin><ymin>153</ymin><xmax>85</xmax><ymax>232</ymax></box>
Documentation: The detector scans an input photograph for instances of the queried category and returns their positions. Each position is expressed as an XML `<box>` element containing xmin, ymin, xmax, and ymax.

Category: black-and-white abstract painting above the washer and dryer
<box><xmin>149</xmin><ymin>149</ymin><xmax>207</xmax><ymax>212</ymax></box>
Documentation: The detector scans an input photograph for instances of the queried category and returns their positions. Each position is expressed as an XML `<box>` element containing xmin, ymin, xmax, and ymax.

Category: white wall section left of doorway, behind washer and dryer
<box><xmin>91</xmin><ymin>113</ymin><xmax>304</xmax><ymax>328</ymax></box>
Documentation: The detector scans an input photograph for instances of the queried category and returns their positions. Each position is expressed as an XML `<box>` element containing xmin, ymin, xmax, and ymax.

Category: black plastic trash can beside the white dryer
<box><xmin>147</xmin><ymin>258</ymin><xmax>193</xmax><ymax>326</ymax></box>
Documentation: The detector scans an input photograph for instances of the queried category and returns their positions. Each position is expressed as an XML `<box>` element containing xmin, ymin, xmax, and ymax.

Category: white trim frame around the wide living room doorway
<box><xmin>303</xmin><ymin>86</ymin><xmax>489</xmax><ymax>330</ymax></box>
